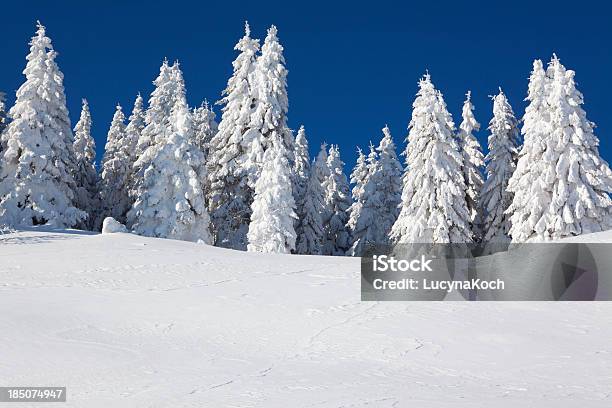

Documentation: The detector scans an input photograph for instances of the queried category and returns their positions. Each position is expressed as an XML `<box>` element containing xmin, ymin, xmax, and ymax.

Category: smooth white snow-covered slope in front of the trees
<box><xmin>0</xmin><ymin>230</ymin><xmax>612</xmax><ymax>408</ymax></box>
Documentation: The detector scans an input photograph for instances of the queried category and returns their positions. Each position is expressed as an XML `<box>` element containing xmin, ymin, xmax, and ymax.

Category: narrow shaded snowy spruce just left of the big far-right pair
<box><xmin>481</xmin><ymin>88</ymin><xmax>519</xmax><ymax>244</ymax></box>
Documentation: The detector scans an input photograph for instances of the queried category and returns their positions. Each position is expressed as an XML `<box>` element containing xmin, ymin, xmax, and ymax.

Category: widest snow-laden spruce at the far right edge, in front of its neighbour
<box><xmin>507</xmin><ymin>56</ymin><xmax>612</xmax><ymax>242</ymax></box>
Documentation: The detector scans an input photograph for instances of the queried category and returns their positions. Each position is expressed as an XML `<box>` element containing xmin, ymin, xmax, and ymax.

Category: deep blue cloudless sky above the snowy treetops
<box><xmin>0</xmin><ymin>0</ymin><xmax>612</xmax><ymax>173</ymax></box>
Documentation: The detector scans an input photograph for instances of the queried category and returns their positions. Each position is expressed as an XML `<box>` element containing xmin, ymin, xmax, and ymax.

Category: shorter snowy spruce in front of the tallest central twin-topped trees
<box><xmin>247</xmin><ymin>139</ymin><xmax>297</xmax><ymax>254</ymax></box>
